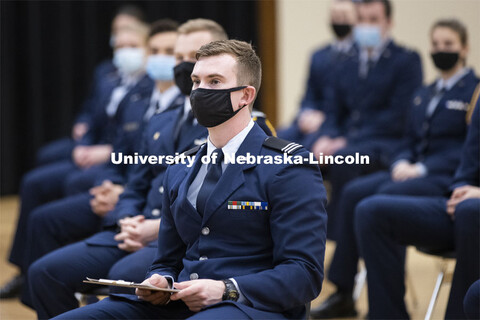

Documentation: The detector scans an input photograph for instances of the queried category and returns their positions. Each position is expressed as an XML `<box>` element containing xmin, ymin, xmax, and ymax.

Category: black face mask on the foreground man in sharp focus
<box><xmin>190</xmin><ymin>86</ymin><xmax>247</xmax><ymax>128</ymax></box>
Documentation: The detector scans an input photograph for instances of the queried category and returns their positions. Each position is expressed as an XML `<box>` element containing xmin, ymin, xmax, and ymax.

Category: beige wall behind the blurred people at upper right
<box><xmin>277</xmin><ymin>0</ymin><xmax>480</xmax><ymax>125</ymax></box>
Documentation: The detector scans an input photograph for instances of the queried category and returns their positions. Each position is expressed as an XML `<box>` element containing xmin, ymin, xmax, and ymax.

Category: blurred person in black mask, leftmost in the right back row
<box><xmin>278</xmin><ymin>0</ymin><xmax>357</xmax><ymax>149</ymax></box>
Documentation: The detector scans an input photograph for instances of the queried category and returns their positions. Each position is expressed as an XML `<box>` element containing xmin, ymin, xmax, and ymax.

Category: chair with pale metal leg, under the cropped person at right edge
<box><xmin>417</xmin><ymin>247</ymin><xmax>455</xmax><ymax>320</ymax></box>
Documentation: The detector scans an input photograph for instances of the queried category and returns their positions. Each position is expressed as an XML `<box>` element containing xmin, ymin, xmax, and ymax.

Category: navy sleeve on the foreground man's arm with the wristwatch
<box><xmin>235</xmin><ymin>153</ymin><xmax>327</xmax><ymax>312</ymax></box>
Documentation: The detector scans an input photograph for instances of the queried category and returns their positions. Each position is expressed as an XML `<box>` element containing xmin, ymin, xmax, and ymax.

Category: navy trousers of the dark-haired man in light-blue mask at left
<box><xmin>22</xmin><ymin>193</ymin><xmax>101</xmax><ymax>305</ymax></box>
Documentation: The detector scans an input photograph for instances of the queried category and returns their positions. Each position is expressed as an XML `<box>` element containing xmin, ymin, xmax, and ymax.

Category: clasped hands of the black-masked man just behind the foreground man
<box><xmin>115</xmin><ymin>215</ymin><xmax>160</xmax><ymax>252</ymax></box>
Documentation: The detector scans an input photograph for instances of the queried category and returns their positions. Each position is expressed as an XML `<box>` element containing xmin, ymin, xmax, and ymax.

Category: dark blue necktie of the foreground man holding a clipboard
<box><xmin>197</xmin><ymin>149</ymin><xmax>223</xmax><ymax>217</ymax></box>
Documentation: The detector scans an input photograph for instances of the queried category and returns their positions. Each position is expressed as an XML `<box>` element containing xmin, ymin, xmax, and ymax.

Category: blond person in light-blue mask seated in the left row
<box><xmin>1</xmin><ymin>28</ymin><xmax>153</xmax><ymax>298</ymax></box>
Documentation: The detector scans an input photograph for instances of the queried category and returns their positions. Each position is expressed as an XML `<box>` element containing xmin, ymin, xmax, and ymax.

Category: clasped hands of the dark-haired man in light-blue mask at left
<box><xmin>90</xmin><ymin>180</ymin><xmax>124</xmax><ymax>217</ymax></box>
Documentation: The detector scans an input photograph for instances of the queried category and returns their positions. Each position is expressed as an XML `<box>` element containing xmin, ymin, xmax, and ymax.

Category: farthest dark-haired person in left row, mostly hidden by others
<box><xmin>36</xmin><ymin>5</ymin><xmax>145</xmax><ymax>166</ymax></box>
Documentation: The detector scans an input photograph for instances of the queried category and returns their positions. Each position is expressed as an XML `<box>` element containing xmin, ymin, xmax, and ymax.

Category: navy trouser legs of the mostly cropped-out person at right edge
<box><xmin>355</xmin><ymin>195</ymin><xmax>480</xmax><ymax>319</ymax></box>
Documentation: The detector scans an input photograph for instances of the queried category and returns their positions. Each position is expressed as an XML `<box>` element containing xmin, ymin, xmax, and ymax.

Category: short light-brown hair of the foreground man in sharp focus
<box><xmin>196</xmin><ymin>40</ymin><xmax>262</xmax><ymax>93</ymax></box>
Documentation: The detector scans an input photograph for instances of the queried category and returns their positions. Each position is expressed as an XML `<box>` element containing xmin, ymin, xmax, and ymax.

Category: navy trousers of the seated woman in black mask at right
<box><xmin>328</xmin><ymin>171</ymin><xmax>449</xmax><ymax>291</ymax></box>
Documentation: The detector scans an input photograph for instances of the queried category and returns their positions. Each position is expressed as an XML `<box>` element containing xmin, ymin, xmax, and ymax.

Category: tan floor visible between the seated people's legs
<box><xmin>0</xmin><ymin>196</ymin><xmax>454</xmax><ymax>320</ymax></box>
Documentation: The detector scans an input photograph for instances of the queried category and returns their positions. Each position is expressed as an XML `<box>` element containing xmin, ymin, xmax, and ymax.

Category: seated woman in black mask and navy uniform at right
<box><xmin>312</xmin><ymin>20</ymin><xmax>479</xmax><ymax>318</ymax></box>
